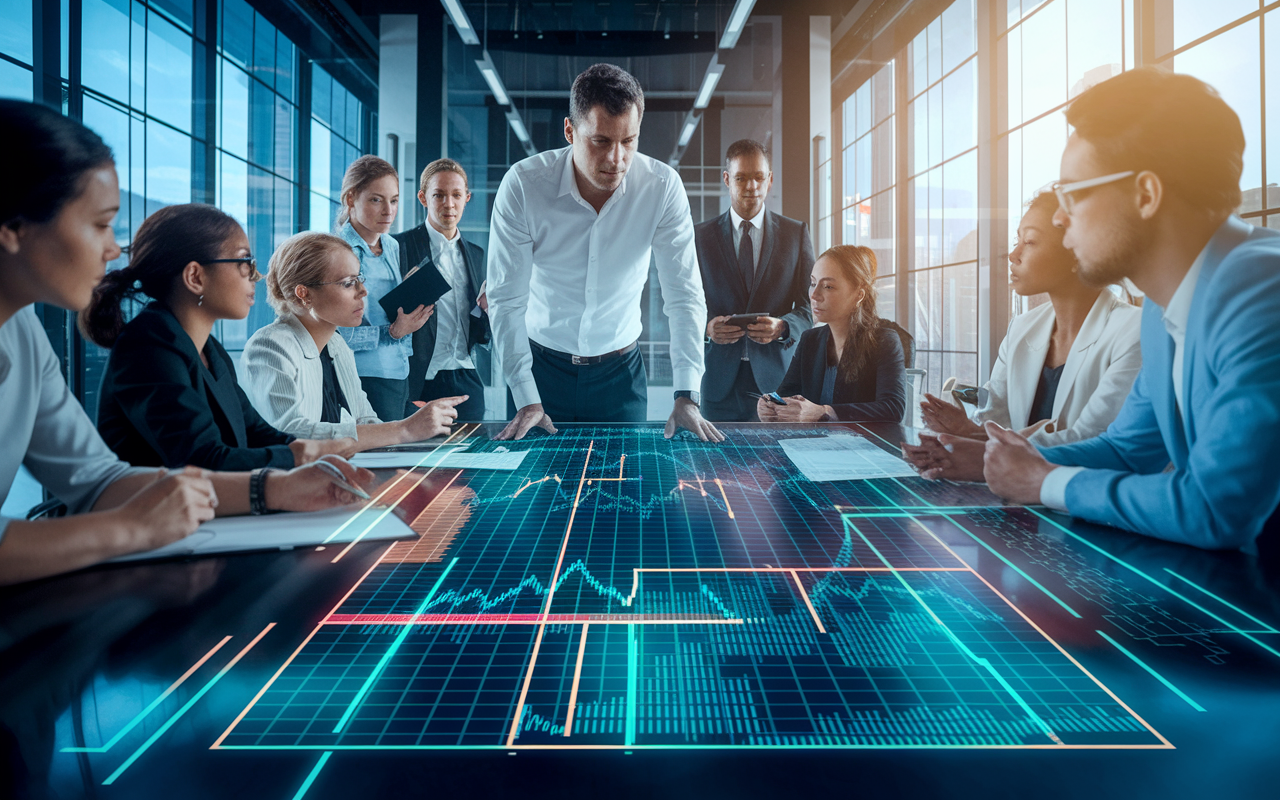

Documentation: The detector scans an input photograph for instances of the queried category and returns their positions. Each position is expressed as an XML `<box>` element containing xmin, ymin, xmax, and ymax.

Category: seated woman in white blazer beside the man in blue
<box><xmin>920</xmin><ymin>192</ymin><xmax>1142</xmax><ymax>445</ymax></box>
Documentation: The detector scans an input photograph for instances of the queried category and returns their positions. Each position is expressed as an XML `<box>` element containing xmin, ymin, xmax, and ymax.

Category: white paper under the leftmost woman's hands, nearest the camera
<box><xmin>111</xmin><ymin>503</ymin><xmax>416</xmax><ymax>561</ymax></box>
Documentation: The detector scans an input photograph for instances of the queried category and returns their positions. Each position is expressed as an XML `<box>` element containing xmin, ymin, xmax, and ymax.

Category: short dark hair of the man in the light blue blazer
<box><xmin>1066</xmin><ymin>67</ymin><xmax>1244</xmax><ymax>214</ymax></box>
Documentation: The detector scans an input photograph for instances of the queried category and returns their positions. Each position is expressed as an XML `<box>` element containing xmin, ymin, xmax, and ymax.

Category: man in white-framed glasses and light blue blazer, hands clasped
<box><xmin>916</xmin><ymin>69</ymin><xmax>1280</xmax><ymax>553</ymax></box>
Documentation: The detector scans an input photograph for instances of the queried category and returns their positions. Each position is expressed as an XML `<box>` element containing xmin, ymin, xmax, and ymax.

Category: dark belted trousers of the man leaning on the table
<box><xmin>507</xmin><ymin>346</ymin><xmax>649</xmax><ymax>424</ymax></box>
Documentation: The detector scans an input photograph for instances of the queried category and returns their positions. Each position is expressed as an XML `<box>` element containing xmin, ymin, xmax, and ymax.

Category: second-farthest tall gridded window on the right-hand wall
<box><xmin>900</xmin><ymin>0</ymin><xmax>980</xmax><ymax>393</ymax></box>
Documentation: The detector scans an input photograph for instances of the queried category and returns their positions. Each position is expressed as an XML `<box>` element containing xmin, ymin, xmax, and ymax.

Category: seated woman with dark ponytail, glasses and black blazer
<box><xmin>81</xmin><ymin>204</ymin><xmax>352</xmax><ymax>470</ymax></box>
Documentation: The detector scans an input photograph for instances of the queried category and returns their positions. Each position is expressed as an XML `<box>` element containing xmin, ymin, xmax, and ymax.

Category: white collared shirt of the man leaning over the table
<box><xmin>489</xmin><ymin>147</ymin><xmax>707</xmax><ymax>407</ymax></box>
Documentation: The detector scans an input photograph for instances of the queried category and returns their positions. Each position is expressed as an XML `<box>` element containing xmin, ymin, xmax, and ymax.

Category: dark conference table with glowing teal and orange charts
<box><xmin>0</xmin><ymin>424</ymin><xmax>1280</xmax><ymax>800</ymax></box>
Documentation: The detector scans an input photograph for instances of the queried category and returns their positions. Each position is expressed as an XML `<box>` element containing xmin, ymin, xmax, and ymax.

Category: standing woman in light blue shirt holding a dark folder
<box><xmin>338</xmin><ymin>156</ymin><xmax>435</xmax><ymax>422</ymax></box>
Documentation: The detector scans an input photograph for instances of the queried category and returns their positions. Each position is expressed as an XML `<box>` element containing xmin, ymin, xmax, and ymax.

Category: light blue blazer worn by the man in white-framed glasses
<box><xmin>1041</xmin><ymin>216</ymin><xmax>1280</xmax><ymax>554</ymax></box>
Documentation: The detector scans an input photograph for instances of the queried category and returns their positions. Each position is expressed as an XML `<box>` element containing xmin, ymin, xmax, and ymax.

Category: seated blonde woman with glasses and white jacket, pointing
<box><xmin>241</xmin><ymin>233</ymin><xmax>467</xmax><ymax>452</ymax></box>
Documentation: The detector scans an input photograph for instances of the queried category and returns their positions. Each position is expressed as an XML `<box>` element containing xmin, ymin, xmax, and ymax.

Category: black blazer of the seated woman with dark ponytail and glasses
<box><xmin>97</xmin><ymin>302</ymin><xmax>293</xmax><ymax>471</ymax></box>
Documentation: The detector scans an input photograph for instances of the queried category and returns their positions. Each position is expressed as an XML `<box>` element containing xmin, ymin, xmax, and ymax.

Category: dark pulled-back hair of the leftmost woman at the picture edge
<box><xmin>0</xmin><ymin>100</ymin><xmax>113</xmax><ymax>225</ymax></box>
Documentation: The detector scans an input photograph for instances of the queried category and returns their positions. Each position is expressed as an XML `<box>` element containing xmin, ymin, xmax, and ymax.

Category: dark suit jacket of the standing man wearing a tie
<box><xmin>694</xmin><ymin>211</ymin><xmax>814</xmax><ymax>401</ymax></box>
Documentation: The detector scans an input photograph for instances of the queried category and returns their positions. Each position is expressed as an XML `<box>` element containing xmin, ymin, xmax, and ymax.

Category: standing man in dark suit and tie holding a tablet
<box><xmin>694</xmin><ymin>140</ymin><xmax>814</xmax><ymax>422</ymax></box>
